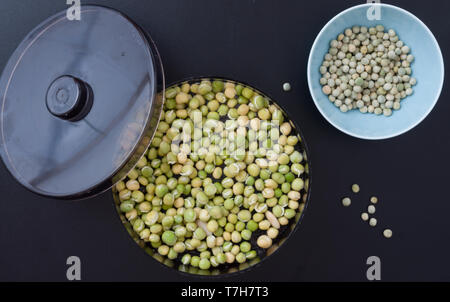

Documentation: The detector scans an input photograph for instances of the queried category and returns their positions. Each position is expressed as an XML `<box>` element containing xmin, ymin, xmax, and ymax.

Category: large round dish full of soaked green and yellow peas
<box><xmin>113</xmin><ymin>78</ymin><xmax>310</xmax><ymax>275</ymax></box>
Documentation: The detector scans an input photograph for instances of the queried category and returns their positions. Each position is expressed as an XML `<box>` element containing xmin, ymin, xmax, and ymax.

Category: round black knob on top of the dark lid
<box><xmin>46</xmin><ymin>75</ymin><xmax>93</xmax><ymax>122</ymax></box>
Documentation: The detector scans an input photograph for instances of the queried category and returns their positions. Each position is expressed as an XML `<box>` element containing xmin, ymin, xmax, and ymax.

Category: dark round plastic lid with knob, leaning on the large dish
<box><xmin>0</xmin><ymin>6</ymin><xmax>164</xmax><ymax>199</ymax></box>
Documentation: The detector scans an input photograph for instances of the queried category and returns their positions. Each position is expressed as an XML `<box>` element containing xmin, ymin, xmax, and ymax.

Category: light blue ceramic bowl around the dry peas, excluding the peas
<box><xmin>307</xmin><ymin>4</ymin><xmax>444</xmax><ymax>140</ymax></box>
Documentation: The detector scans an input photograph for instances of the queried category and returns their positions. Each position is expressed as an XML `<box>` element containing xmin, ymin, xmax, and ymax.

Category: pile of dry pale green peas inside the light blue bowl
<box><xmin>320</xmin><ymin>25</ymin><xmax>417</xmax><ymax>116</ymax></box>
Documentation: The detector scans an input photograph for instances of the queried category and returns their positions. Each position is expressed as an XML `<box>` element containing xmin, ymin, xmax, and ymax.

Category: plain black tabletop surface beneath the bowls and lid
<box><xmin>0</xmin><ymin>0</ymin><xmax>450</xmax><ymax>281</ymax></box>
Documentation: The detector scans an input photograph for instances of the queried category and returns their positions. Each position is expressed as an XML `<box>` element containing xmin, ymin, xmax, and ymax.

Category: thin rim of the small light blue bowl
<box><xmin>307</xmin><ymin>3</ymin><xmax>445</xmax><ymax>140</ymax></box>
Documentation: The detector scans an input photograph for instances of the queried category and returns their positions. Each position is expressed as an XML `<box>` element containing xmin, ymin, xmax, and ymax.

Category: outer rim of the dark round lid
<box><xmin>0</xmin><ymin>5</ymin><xmax>164</xmax><ymax>200</ymax></box>
